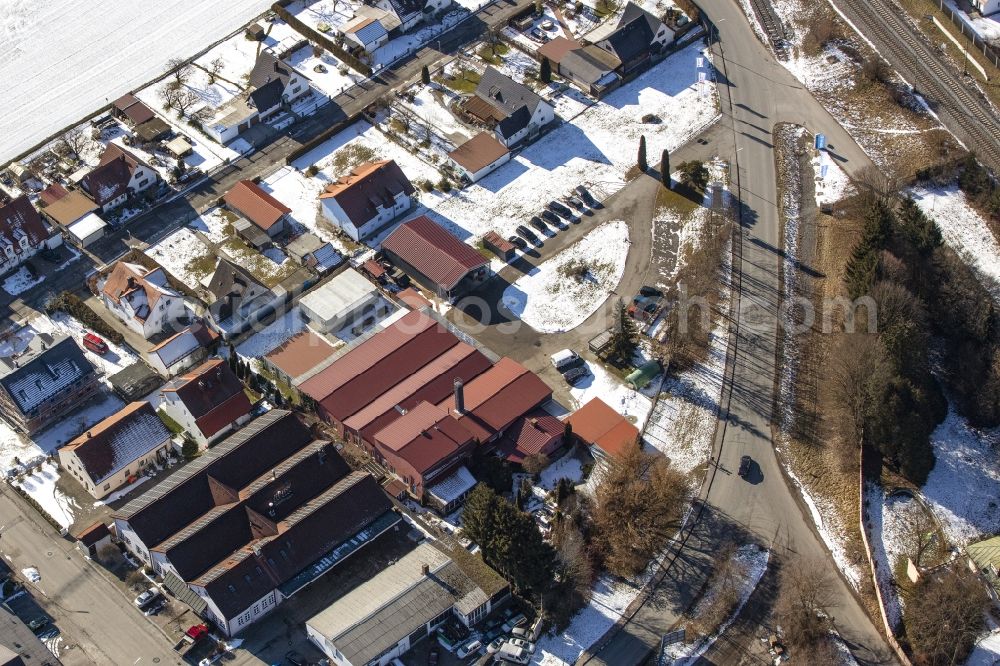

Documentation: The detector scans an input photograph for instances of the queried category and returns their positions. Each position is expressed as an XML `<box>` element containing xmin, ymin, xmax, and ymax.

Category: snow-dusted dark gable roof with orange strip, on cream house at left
<box><xmin>63</xmin><ymin>402</ymin><xmax>170</xmax><ymax>485</ymax></box>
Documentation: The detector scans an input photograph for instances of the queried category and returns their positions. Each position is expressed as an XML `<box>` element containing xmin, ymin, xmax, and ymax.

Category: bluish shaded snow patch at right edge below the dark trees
<box><xmin>922</xmin><ymin>410</ymin><xmax>1000</xmax><ymax>546</ymax></box>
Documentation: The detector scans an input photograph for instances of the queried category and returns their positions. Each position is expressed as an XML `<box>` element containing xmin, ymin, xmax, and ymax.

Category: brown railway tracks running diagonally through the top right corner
<box><xmin>835</xmin><ymin>0</ymin><xmax>1000</xmax><ymax>173</ymax></box>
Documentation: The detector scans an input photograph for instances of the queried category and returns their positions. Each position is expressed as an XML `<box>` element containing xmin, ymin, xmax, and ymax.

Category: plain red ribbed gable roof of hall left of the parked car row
<box><xmin>382</xmin><ymin>215</ymin><xmax>488</xmax><ymax>290</ymax></box>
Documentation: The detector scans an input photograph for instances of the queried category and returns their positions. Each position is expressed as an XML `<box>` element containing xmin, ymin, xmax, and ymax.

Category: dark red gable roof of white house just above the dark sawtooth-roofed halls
<box><xmin>163</xmin><ymin>358</ymin><xmax>251</xmax><ymax>437</ymax></box>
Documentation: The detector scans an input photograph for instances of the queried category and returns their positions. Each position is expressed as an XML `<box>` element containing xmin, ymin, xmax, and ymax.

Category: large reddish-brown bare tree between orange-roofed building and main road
<box><xmin>593</xmin><ymin>442</ymin><xmax>687</xmax><ymax>577</ymax></box>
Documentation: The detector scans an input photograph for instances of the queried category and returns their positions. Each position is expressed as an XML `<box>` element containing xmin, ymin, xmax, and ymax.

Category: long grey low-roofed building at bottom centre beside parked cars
<box><xmin>306</xmin><ymin>542</ymin><xmax>509</xmax><ymax>666</ymax></box>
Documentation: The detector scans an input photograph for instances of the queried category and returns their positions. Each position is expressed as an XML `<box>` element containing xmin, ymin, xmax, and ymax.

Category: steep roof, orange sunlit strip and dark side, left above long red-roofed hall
<box><xmin>319</xmin><ymin>160</ymin><xmax>416</xmax><ymax>226</ymax></box>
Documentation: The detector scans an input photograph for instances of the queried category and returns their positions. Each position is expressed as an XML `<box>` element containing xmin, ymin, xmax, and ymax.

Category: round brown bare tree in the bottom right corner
<box><xmin>903</xmin><ymin>565</ymin><xmax>990</xmax><ymax>666</ymax></box>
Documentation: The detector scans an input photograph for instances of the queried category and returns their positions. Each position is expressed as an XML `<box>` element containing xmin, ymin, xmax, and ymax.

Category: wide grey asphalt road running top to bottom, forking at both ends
<box><xmin>579</xmin><ymin>0</ymin><xmax>893</xmax><ymax>666</ymax></box>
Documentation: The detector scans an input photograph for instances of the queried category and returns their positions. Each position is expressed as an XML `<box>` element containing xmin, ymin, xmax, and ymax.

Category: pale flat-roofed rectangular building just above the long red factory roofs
<box><xmin>299</xmin><ymin>266</ymin><xmax>393</xmax><ymax>336</ymax></box>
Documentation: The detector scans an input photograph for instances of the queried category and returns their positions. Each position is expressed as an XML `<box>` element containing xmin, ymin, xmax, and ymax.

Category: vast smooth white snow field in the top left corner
<box><xmin>0</xmin><ymin>0</ymin><xmax>270</xmax><ymax>164</ymax></box>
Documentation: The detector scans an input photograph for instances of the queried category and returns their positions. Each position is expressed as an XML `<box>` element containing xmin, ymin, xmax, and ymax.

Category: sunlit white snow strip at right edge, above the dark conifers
<box><xmin>910</xmin><ymin>185</ymin><xmax>1000</xmax><ymax>303</ymax></box>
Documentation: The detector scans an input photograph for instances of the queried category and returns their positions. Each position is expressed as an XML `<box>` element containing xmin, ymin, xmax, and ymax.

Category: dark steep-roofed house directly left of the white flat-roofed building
<box><xmin>207</xmin><ymin>259</ymin><xmax>281</xmax><ymax>339</ymax></box>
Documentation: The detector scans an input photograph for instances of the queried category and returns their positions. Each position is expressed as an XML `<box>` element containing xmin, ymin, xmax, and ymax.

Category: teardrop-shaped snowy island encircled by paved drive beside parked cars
<box><xmin>503</xmin><ymin>220</ymin><xmax>629</xmax><ymax>333</ymax></box>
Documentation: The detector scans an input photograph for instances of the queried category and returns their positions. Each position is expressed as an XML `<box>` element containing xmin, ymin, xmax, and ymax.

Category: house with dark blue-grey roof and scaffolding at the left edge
<box><xmin>0</xmin><ymin>326</ymin><xmax>100</xmax><ymax>436</ymax></box>
